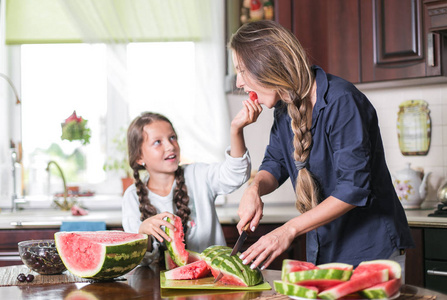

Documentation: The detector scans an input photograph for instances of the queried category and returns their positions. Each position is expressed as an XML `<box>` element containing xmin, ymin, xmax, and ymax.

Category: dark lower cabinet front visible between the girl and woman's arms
<box><xmin>222</xmin><ymin>224</ymin><xmax>306</xmax><ymax>270</ymax></box>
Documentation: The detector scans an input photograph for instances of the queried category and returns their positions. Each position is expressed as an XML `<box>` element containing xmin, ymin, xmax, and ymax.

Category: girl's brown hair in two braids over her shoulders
<box><xmin>127</xmin><ymin>112</ymin><xmax>191</xmax><ymax>232</ymax></box>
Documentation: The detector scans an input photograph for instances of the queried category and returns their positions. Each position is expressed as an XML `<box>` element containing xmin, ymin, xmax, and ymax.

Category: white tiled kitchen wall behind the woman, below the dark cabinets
<box><xmin>227</xmin><ymin>83</ymin><xmax>447</xmax><ymax>208</ymax></box>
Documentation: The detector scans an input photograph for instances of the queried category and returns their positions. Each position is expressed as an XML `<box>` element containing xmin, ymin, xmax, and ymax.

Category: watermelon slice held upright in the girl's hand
<box><xmin>165</xmin><ymin>216</ymin><xmax>189</xmax><ymax>266</ymax></box>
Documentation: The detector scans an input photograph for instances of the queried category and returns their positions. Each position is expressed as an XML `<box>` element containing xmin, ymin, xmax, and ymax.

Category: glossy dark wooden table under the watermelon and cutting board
<box><xmin>0</xmin><ymin>267</ymin><xmax>447</xmax><ymax>300</ymax></box>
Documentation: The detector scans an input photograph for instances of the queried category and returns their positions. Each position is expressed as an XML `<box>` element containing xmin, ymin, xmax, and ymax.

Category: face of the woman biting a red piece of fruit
<box><xmin>232</xmin><ymin>51</ymin><xmax>280</xmax><ymax>108</ymax></box>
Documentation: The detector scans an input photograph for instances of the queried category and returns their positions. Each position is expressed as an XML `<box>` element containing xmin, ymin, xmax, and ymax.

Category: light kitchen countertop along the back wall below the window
<box><xmin>0</xmin><ymin>204</ymin><xmax>447</xmax><ymax>229</ymax></box>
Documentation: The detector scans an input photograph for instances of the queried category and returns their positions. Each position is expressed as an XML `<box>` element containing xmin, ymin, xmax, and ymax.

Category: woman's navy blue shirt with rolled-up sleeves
<box><xmin>260</xmin><ymin>66</ymin><xmax>414</xmax><ymax>266</ymax></box>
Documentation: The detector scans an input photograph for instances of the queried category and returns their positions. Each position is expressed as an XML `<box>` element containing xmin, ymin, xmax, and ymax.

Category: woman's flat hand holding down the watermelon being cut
<box><xmin>239</xmin><ymin>225</ymin><xmax>295</xmax><ymax>270</ymax></box>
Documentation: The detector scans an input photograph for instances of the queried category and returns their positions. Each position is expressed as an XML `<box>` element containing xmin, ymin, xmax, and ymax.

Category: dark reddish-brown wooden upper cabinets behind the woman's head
<box><xmin>275</xmin><ymin>0</ymin><xmax>447</xmax><ymax>83</ymax></box>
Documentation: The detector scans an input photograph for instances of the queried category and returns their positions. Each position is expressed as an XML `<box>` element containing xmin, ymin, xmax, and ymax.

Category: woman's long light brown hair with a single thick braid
<box><xmin>229</xmin><ymin>21</ymin><xmax>318</xmax><ymax>212</ymax></box>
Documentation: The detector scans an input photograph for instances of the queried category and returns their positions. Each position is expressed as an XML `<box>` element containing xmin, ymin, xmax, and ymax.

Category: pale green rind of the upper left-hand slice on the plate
<box><xmin>283</xmin><ymin>269</ymin><xmax>352</xmax><ymax>283</ymax></box>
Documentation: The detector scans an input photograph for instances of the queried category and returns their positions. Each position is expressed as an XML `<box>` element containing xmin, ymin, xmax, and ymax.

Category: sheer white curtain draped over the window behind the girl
<box><xmin>57</xmin><ymin>0</ymin><xmax>230</xmax><ymax>161</ymax></box>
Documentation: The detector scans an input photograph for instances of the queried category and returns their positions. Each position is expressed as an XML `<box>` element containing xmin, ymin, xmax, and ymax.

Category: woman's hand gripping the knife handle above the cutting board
<box><xmin>237</xmin><ymin>184</ymin><xmax>264</xmax><ymax>233</ymax></box>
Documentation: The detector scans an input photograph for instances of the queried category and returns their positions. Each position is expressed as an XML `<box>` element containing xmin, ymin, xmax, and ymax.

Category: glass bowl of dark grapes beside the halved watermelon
<box><xmin>19</xmin><ymin>240</ymin><xmax>66</xmax><ymax>275</ymax></box>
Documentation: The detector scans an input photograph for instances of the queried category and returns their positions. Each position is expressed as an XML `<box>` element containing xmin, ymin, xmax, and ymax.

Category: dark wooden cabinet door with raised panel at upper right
<box><xmin>360</xmin><ymin>0</ymin><xmax>439</xmax><ymax>82</ymax></box>
